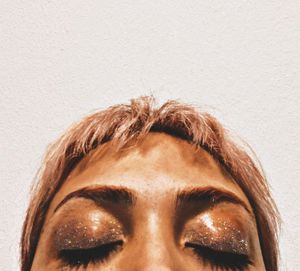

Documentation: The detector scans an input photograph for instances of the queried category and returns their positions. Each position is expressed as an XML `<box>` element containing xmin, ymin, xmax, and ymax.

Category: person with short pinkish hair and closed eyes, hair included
<box><xmin>21</xmin><ymin>96</ymin><xmax>279</xmax><ymax>271</ymax></box>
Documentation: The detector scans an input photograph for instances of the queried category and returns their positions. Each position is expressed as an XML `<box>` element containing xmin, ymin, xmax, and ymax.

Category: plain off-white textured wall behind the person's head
<box><xmin>0</xmin><ymin>0</ymin><xmax>300</xmax><ymax>271</ymax></box>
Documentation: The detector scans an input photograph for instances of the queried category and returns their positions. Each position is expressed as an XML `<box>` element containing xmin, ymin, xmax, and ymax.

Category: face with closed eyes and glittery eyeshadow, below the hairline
<box><xmin>31</xmin><ymin>133</ymin><xmax>265</xmax><ymax>271</ymax></box>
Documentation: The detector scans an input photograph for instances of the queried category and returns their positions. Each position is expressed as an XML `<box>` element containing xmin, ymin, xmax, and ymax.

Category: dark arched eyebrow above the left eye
<box><xmin>54</xmin><ymin>186</ymin><xmax>136</xmax><ymax>213</ymax></box>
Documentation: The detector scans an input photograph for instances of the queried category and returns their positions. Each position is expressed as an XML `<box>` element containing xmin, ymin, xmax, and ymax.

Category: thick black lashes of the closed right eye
<box><xmin>185</xmin><ymin>242</ymin><xmax>253</xmax><ymax>271</ymax></box>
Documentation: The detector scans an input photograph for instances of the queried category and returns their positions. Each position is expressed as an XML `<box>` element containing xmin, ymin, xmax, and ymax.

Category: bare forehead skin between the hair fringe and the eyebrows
<box><xmin>48</xmin><ymin>133</ymin><xmax>250</xmax><ymax>212</ymax></box>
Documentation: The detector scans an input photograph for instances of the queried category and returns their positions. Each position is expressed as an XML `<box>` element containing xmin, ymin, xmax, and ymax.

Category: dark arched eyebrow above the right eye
<box><xmin>176</xmin><ymin>187</ymin><xmax>253</xmax><ymax>216</ymax></box>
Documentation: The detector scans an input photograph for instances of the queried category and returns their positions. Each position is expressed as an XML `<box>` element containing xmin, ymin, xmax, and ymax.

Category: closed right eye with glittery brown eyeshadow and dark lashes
<box><xmin>183</xmin><ymin>208</ymin><xmax>253</xmax><ymax>271</ymax></box>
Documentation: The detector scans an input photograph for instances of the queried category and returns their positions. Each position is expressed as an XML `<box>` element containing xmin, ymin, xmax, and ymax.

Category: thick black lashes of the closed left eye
<box><xmin>59</xmin><ymin>240</ymin><xmax>123</xmax><ymax>270</ymax></box>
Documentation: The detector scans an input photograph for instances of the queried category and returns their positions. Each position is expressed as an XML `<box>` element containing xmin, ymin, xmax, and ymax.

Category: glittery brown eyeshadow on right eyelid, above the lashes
<box><xmin>184</xmin><ymin>214</ymin><xmax>250</xmax><ymax>255</ymax></box>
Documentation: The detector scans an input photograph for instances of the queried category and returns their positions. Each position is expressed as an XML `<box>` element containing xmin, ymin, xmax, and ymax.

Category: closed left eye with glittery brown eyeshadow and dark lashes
<box><xmin>52</xmin><ymin>210</ymin><xmax>125</xmax><ymax>270</ymax></box>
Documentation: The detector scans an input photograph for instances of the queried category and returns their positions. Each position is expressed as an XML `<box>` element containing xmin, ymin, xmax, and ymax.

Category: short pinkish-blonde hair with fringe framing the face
<box><xmin>21</xmin><ymin>96</ymin><xmax>280</xmax><ymax>271</ymax></box>
